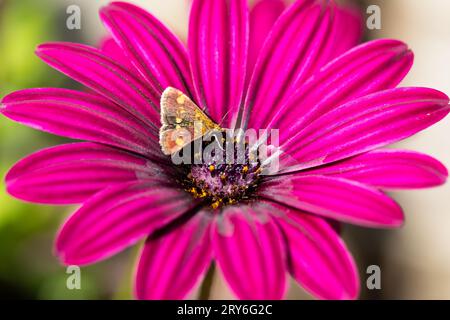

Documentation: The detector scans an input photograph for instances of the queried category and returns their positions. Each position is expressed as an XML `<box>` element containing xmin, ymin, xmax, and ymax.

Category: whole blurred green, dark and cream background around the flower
<box><xmin>0</xmin><ymin>0</ymin><xmax>450</xmax><ymax>299</ymax></box>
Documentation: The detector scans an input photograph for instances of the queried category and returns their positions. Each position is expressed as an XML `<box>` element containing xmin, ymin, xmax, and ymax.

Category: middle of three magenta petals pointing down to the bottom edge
<box><xmin>213</xmin><ymin>206</ymin><xmax>286</xmax><ymax>300</ymax></box>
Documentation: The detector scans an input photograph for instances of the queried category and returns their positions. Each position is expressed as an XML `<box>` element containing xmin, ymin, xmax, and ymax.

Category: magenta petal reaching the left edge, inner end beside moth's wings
<box><xmin>0</xmin><ymin>88</ymin><xmax>160</xmax><ymax>156</ymax></box>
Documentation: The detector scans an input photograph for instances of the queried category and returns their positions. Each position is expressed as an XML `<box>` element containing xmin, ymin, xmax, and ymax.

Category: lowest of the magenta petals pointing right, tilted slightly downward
<box><xmin>259</xmin><ymin>176</ymin><xmax>404</xmax><ymax>227</ymax></box>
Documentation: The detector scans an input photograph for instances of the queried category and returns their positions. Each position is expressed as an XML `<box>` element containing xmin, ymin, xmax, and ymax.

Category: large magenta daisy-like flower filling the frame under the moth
<box><xmin>1</xmin><ymin>0</ymin><xmax>450</xmax><ymax>299</ymax></box>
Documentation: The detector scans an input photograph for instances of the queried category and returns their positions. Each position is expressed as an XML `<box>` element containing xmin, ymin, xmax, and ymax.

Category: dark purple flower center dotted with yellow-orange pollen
<box><xmin>183</xmin><ymin>139</ymin><xmax>261</xmax><ymax>209</ymax></box>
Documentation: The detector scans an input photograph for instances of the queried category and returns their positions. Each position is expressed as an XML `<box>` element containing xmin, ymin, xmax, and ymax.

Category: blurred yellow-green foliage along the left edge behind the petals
<box><xmin>0</xmin><ymin>0</ymin><xmax>132</xmax><ymax>299</ymax></box>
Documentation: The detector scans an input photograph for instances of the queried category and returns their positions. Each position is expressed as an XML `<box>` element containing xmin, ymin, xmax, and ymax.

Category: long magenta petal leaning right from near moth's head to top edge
<box><xmin>236</xmin><ymin>0</ymin><xmax>333</xmax><ymax>128</ymax></box>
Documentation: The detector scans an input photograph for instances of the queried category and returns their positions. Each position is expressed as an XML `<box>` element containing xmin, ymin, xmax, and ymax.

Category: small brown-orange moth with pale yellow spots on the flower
<box><xmin>159</xmin><ymin>87</ymin><xmax>222</xmax><ymax>155</ymax></box>
